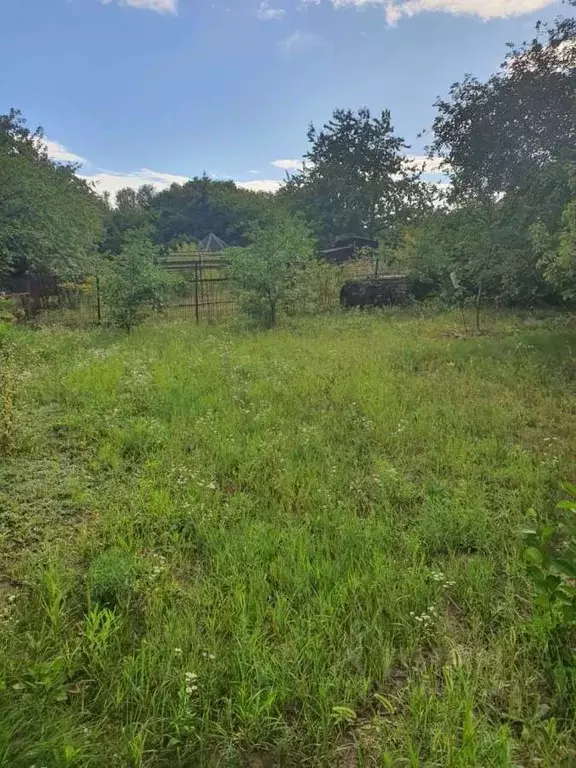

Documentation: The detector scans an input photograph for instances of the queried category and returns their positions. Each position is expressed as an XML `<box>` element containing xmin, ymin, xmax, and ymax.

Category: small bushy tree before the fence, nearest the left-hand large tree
<box><xmin>104</xmin><ymin>232</ymin><xmax>173</xmax><ymax>333</ymax></box>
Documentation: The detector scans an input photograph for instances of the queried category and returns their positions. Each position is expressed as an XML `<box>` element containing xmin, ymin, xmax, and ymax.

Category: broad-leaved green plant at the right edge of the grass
<box><xmin>524</xmin><ymin>484</ymin><xmax>576</xmax><ymax>629</ymax></box>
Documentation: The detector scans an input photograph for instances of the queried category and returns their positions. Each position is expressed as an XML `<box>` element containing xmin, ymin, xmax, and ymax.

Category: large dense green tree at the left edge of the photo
<box><xmin>0</xmin><ymin>109</ymin><xmax>104</xmax><ymax>276</ymax></box>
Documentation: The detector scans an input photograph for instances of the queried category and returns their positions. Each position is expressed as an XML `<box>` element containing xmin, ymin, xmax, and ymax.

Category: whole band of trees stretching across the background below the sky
<box><xmin>0</xmin><ymin>0</ymin><xmax>576</xmax><ymax>306</ymax></box>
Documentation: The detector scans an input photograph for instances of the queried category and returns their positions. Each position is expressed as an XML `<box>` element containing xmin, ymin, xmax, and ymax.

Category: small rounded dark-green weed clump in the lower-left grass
<box><xmin>87</xmin><ymin>548</ymin><xmax>138</xmax><ymax>608</ymax></box>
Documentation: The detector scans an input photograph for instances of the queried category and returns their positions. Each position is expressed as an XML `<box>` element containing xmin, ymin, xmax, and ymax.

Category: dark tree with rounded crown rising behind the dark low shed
<box><xmin>279</xmin><ymin>109</ymin><xmax>422</xmax><ymax>245</ymax></box>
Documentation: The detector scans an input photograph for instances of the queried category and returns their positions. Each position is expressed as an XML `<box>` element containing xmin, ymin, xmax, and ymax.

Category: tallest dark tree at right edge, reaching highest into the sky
<box><xmin>420</xmin><ymin>0</ymin><xmax>576</xmax><ymax>310</ymax></box>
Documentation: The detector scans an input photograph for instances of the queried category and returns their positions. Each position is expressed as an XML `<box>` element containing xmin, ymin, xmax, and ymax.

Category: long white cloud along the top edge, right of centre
<box><xmin>332</xmin><ymin>0</ymin><xmax>556</xmax><ymax>25</ymax></box>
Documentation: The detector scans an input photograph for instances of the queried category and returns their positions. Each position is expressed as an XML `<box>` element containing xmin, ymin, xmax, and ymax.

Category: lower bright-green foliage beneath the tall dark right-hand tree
<box><xmin>395</xmin><ymin>159</ymin><xmax>572</xmax><ymax>306</ymax></box>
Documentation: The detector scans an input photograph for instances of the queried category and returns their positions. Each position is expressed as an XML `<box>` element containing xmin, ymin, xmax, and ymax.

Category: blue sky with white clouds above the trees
<box><xmin>0</xmin><ymin>0</ymin><xmax>563</xmax><ymax>194</ymax></box>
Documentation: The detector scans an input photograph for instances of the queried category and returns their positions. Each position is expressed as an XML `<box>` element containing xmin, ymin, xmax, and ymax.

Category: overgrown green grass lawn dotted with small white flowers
<box><xmin>0</xmin><ymin>312</ymin><xmax>576</xmax><ymax>768</ymax></box>
